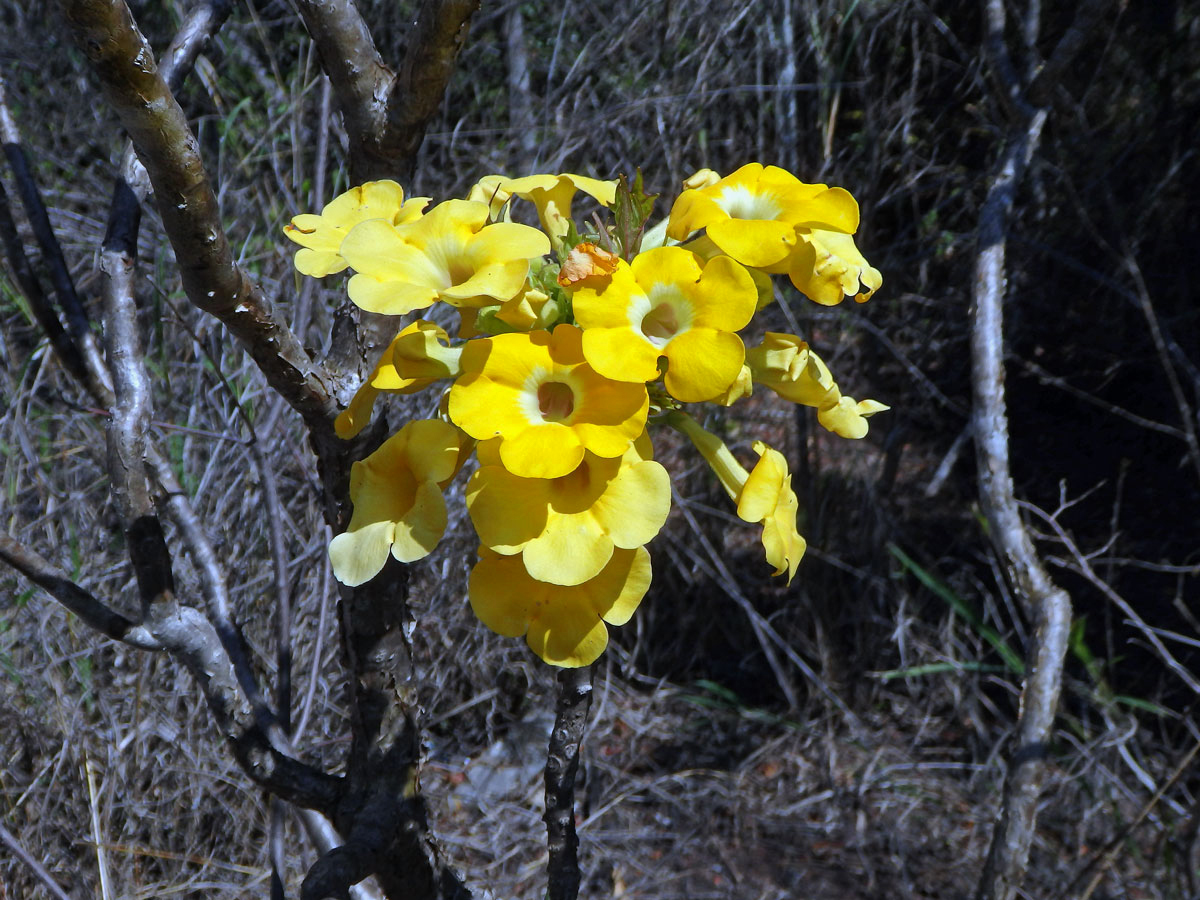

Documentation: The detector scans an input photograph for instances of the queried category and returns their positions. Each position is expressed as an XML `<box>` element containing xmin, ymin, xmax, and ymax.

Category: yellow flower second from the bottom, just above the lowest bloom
<box><xmin>467</xmin><ymin>432</ymin><xmax>671</xmax><ymax>586</ymax></box>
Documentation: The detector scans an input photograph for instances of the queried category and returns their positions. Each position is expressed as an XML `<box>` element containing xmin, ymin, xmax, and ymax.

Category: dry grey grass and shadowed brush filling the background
<box><xmin>0</xmin><ymin>0</ymin><xmax>1200</xmax><ymax>900</ymax></box>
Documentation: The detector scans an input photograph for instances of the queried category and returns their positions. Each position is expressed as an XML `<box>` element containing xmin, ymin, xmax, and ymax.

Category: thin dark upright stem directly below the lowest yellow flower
<box><xmin>542</xmin><ymin>667</ymin><xmax>592</xmax><ymax>900</ymax></box>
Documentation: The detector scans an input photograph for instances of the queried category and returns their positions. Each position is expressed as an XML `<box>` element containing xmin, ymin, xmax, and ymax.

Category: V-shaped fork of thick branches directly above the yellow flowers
<box><xmin>298</xmin><ymin>0</ymin><xmax>479</xmax><ymax>184</ymax></box>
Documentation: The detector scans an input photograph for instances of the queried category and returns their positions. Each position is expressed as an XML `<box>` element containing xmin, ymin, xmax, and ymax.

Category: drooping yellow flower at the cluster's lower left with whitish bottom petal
<box><xmin>329</xmin><ymin>419</ymin><xmax>467</xmax><ymax>587</ymax></box>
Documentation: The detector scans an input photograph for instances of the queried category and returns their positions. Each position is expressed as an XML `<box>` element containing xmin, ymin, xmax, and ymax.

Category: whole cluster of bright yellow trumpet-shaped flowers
<box><xmin>284</xmin><ymin>163</ymin><xmax>887</xmax><ymax>666</ymax></box>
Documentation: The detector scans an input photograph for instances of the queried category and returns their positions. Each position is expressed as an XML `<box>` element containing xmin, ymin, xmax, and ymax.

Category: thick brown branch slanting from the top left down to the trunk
<box><xmin>61</xmin><ymin>0</ymin><xmax>337</xmax><ymax>440</ymax></box>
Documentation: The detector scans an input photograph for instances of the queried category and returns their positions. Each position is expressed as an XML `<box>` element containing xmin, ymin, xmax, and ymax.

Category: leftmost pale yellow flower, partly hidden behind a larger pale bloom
<box><xmin>283</xmin><ymin>181</ymin><xmax>430</xmax><ymax>278</ymax></box>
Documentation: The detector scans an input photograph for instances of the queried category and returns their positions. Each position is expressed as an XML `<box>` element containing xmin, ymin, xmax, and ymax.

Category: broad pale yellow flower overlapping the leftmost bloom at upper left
<box><xmin>341</xmin><ymin>200</ymin><xmax>550</xmax><ymax>316</ymax></box>
